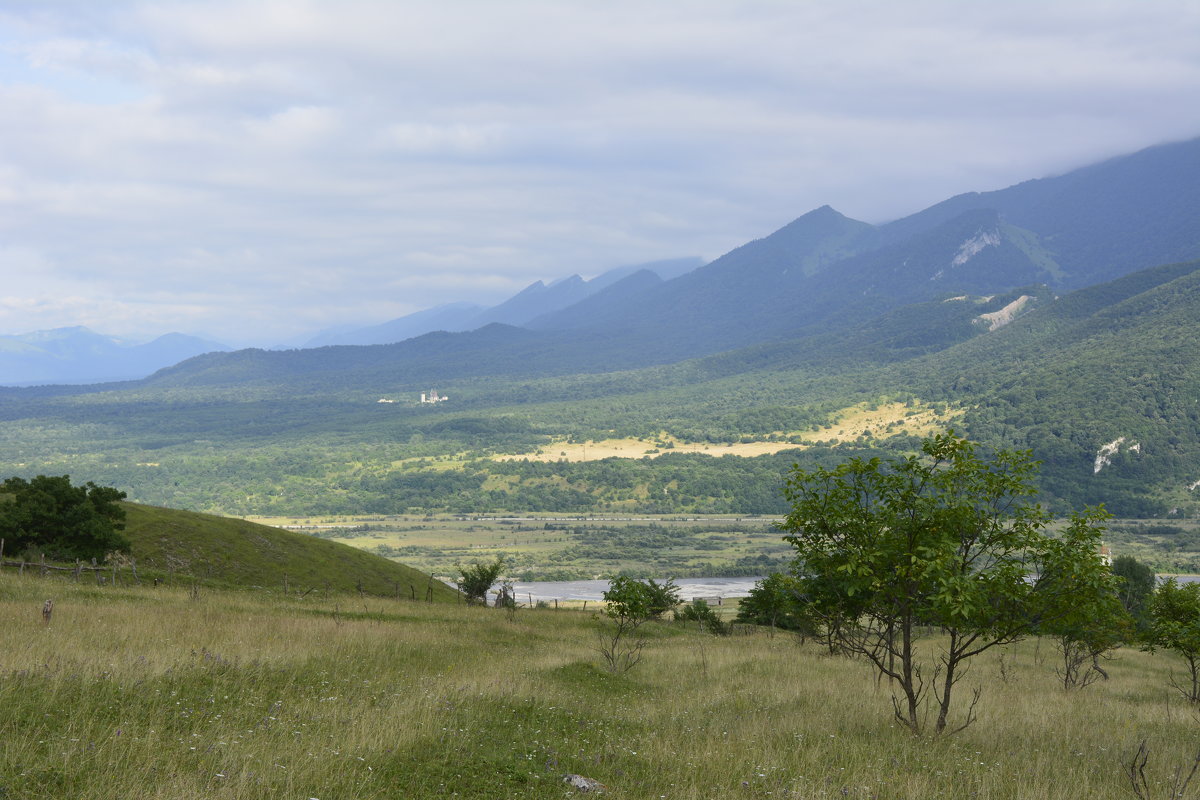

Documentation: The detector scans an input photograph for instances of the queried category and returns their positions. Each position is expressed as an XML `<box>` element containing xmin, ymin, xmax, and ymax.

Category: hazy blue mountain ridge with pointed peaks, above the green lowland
<box><xmin>140</xmin><ymin>139</ymin><xmax>1200</xmax><ymax>384</ymax></box>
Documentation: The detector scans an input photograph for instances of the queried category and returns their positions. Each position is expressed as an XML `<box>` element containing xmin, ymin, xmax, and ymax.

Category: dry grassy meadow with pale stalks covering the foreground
<box><xmin>0</xmin><ymin>571</ymin><xmax>1200</xmax><ymax>800</ymax></box>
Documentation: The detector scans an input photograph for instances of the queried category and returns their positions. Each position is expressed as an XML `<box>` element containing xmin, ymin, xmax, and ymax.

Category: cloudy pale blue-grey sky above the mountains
<box><xmin>0</xmin><ymin>0</ymin><xmax>1200</xmax><ymax>347</ymax></box>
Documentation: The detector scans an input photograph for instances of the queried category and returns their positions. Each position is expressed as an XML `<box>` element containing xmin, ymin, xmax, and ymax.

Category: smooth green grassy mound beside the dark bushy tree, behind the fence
<box><xmin>125</xmin><ymin>503</ymin><xmax>456</xmax><ymax>602</ymax></box>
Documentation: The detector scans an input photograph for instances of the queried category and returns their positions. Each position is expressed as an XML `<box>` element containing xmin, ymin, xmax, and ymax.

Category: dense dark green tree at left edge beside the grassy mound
<box><xmin>0</xmin><ymin>475</ymin><xmax>131</xmax><ymax>560</ymax></box>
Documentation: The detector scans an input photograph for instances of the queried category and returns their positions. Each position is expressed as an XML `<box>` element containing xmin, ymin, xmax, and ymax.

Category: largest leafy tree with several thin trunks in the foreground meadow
<box><xmin>782</xmin><ymin>432</ymin><xmax>1111</xmax><ymax>734</ymax></box>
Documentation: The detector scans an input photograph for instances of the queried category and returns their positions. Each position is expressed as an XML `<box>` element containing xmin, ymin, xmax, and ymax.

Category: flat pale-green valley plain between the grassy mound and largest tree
<box><xmin>244</xmin><ymin>515</ymin><xmax>792</xmax><ymax>581</ymax></box>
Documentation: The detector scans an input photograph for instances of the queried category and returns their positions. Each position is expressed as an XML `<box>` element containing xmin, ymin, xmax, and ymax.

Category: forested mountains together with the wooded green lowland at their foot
<box><xmin>0</xmin><ymin>139</ymin><xmax>1200</xmax><ymax>516</ymax></box>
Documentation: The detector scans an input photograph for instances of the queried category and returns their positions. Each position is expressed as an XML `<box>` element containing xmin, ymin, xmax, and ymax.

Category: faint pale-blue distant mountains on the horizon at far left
<box><xmin>0</xmin><ymin>327</ymin><xmax>230</xmax><ymax>386</ymax></box>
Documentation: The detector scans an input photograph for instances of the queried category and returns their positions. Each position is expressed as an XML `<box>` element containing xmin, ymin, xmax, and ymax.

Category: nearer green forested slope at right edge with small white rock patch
<box><xmin>881</xmin><ymin>261</ymin><xmax>1200</xmax><ymax>515</ymax></box>
